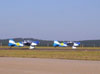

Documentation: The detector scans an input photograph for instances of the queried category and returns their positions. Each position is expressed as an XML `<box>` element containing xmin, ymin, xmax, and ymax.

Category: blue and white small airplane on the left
<box><xmin>8</xmin><ymin>39</ymin><xmax>39</xmax><ymax>49</ymax></box>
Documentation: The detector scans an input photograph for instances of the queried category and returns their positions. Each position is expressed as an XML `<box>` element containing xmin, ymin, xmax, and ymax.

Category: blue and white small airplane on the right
<box><xmin>53</xmin><ymin>40</ymin><xmax>80</xmax><ymax>49</ymax></box>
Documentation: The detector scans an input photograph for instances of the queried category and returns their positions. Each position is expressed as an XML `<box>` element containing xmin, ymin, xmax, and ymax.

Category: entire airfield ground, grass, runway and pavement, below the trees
<box><xmin>0</xmin><ymin>46</ymin><xmax>100</xmax><ymax>74</ymax></box>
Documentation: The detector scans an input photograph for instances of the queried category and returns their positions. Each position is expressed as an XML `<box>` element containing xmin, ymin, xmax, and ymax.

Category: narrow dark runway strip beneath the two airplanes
<box><xmin>0</xmin><ymin>48</ymin><xmax>100</xmax><ymax>51</ymax></box>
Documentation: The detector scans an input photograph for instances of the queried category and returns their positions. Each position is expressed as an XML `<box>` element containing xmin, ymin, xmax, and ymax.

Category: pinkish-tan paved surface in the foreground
<box><xmin>0</xmin><ymin>57</ymin><xmax>100</xmax><ymax>74</ymax></box>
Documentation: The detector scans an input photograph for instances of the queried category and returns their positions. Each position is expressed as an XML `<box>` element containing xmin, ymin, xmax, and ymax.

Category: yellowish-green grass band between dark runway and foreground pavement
<box><xmin>0</xmin><ymin>50</ymin><xmax>100</xmax><ymax>61</ymax></box>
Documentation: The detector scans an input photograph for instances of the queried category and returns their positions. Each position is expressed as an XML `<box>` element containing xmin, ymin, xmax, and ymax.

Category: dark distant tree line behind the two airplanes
<box><xmin>0</xmin><ymin>38</ymin><xmax>100</xmax><ymax>47</ymax></box>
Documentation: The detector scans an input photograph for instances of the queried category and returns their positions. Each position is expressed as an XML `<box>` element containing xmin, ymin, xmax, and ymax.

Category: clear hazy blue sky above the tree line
<box><xmin>0</xmin><ymin>0</ymin><xmax>100</xmax><ymax>41</ymax></box>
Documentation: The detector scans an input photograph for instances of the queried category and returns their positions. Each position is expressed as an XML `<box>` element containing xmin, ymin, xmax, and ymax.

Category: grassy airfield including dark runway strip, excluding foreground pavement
<box><xmin>0</xmin><ymin>46</ymin><xmax>100</xmax><ymax>61</ymax></box>
